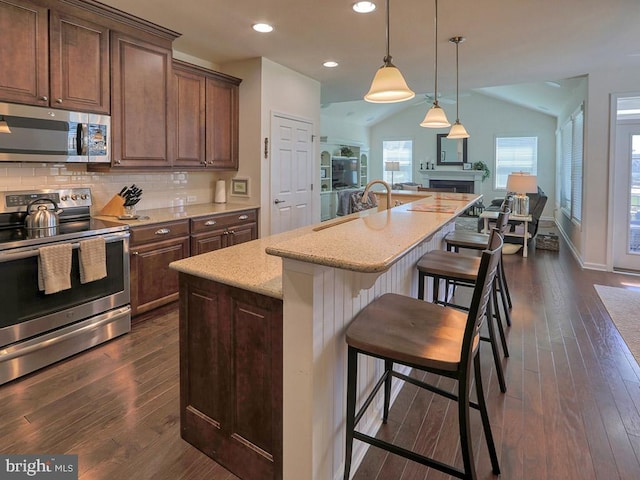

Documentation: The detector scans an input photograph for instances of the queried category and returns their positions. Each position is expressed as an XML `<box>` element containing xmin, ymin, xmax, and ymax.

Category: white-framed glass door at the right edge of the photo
<box><xmin>613</xmin><ymin>124</ymin><xmax>640</xmax><ymax>271</ymax></box>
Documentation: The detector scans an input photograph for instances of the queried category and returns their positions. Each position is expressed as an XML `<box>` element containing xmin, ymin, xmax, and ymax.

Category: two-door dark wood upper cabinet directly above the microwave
<box><xmin>0</xmin><ymin>0</ymin><xmax>110</xmax><ymax>113</ymax></box>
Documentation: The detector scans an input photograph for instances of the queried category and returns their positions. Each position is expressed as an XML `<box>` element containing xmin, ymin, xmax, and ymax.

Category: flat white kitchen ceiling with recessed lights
<box><xmin>103</xmin><ymin>0</ymin><xmax>640</xmax><ymax>114</ymax></box>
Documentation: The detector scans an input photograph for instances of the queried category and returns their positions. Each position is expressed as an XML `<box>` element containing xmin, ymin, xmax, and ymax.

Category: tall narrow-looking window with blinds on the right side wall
<box><xmin>560</xmin><ymin>106</ymin><xmax>584</xmax><ymax>223</ymax></box>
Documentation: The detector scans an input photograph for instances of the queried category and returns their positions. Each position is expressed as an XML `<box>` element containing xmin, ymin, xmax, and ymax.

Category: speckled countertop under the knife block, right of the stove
<box><xmin>94</xmin><ymin>203</ymin><xmax>259</xmax><ymax>227</ymax></box>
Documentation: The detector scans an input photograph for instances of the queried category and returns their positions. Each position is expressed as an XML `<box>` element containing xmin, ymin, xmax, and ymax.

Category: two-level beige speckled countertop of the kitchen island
<box><xmin>170</xmin><ymin>193</ymin><xmax>482</xmax><ymax>298</ymax></box>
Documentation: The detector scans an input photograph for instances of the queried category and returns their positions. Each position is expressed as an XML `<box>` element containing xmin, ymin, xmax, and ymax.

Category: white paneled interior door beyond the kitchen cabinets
<box><xmin>271</xmin><ymin>114</ymin><xmax>314</xmax><ymax>235</ymax></box>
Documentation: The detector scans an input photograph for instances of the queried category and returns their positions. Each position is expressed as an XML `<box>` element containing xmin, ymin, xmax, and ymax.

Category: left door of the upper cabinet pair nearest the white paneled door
<box><xmin>173</xmin><ymin>69</ymin><xmax>207</xmax><ymax>167</ymax></box>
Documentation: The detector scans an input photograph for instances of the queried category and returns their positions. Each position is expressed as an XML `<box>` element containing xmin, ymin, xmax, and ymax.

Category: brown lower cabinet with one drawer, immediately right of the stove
<box><xmin>130</xmin><ymin>220</ymin><xmax>189</xmax><ymax>315</ymax></box>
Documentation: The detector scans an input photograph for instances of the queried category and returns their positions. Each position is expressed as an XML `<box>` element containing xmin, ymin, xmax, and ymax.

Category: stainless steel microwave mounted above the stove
<box><xmin>0</xmin><ymin>103</ymin><xmax>111</xmax><ymax>163</ymax></box>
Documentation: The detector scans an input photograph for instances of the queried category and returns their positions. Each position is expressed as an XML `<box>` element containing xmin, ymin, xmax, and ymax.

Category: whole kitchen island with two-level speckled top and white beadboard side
<box><xmin>171</xmin><ymin>193</ymin><xmax>481</xmax><ymax>480</ymax></box>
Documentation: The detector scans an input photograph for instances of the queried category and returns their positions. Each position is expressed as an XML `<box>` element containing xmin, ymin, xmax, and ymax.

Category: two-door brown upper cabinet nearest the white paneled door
<box><xmin>173</xmin><ymin>60</ymin><xmax>241</xmax><ymax>170</ymax></box>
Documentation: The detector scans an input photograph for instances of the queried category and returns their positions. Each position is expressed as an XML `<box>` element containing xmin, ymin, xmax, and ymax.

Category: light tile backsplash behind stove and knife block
<box><xmin>0</xmin><ymin>163</ymin><xmax>220</xmax><ymax>215</ymax></box>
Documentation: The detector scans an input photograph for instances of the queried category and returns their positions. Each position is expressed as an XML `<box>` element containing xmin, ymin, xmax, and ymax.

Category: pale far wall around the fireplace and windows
<box><xmin>370</xmin><ymin>92</ymin><xmax>556</xmax><ymax>217</ymax></box>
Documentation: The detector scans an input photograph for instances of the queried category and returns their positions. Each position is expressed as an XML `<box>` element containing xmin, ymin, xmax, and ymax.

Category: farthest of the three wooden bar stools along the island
<box><xmin>444</xmin><ymin>208</ymin><xmax>513</xmax><ymax>326</ymax></box>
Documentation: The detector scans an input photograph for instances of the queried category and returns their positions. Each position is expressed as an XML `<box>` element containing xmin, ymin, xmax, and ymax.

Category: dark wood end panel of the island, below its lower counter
<box><xmin>180</xmin><ymin>273</ymin><xmax>282</xmax><ymax>480</ymax></box>
